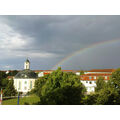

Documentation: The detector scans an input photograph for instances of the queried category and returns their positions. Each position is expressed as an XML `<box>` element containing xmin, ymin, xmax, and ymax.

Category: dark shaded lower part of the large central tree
<box><xmin>39</xmin><ymin>86</ymin><xmax>83</xmax><ymax>105</ymax></box>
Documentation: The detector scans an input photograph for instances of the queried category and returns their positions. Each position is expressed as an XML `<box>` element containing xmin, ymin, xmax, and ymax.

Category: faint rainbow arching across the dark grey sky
<box><xmin>52</xmin><ymin>39</ymin><xmax>120</xmax><ymax>70</ymax></box>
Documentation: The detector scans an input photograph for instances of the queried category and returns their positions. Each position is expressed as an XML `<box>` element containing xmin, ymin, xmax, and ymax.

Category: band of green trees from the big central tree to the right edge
<box><xmin>32</xmin><ymin>68</ymin><xmax>120</xmax><ymax>105</ymax></box>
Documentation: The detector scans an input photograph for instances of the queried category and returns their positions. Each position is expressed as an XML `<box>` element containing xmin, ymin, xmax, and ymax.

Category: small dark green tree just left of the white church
<box><xmin>3</xmin><ymin>80</ymin><xmax>17</xmax><ymax>96</ymax></box>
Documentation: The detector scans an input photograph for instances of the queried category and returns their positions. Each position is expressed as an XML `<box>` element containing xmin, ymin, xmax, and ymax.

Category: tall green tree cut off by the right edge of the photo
<box><xmin>96</xmin><ymin>69</ymin><xmax>120</xmax><ymax>105</ymax></box>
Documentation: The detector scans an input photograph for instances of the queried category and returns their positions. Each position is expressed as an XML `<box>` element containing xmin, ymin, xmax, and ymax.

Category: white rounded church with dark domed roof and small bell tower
<box><xmin>14</xmin><ymin>59</ymin><xmax>38</xmax><ymax>93</ymax></box>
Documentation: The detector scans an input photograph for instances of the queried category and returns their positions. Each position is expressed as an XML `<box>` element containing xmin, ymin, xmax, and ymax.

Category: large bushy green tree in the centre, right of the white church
<box><xmin>35</xmin><ymin>68</ymin><xmax>85</xmax><ymax>105</ymax></box>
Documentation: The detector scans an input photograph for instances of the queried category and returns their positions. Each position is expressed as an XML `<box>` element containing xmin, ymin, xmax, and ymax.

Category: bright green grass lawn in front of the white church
<box><xmin>2</xmin><ymin>95</ymin><xmax>40</xmax><ymax>105</ymax></box>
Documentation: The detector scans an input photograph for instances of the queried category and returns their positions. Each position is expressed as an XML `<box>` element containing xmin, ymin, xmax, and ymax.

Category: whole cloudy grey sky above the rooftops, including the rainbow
<box><xmin>0</xmin><ymin>15</ymin><xmax>120</xmax><ymax>70</ymax></box>
